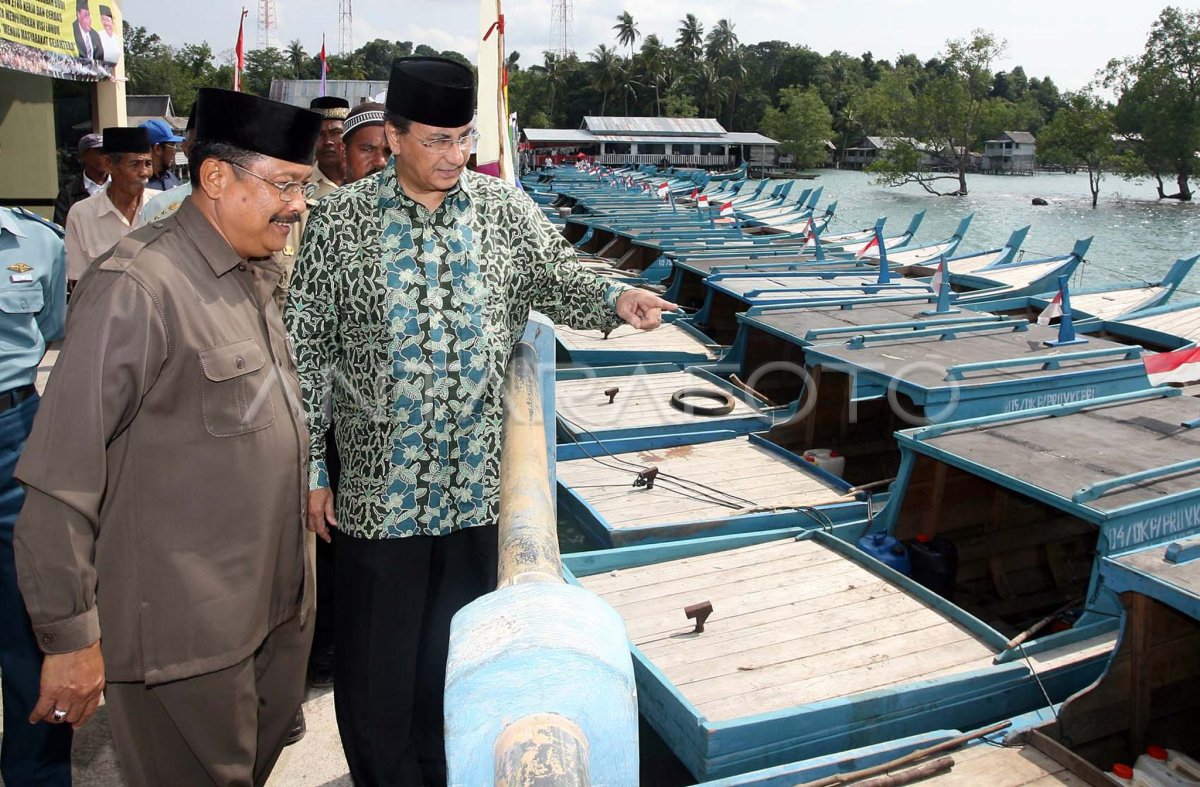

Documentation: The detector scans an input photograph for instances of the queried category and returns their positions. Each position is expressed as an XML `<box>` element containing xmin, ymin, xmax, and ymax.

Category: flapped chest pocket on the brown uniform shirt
<box><xmin>199</xmin><ymin>338</ymin><xmax>275</xmax><ymax>437</ymax></box>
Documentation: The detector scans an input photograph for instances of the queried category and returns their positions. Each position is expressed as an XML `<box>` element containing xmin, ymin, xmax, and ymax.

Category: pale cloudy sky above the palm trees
<box><xmin>121</xmin><ymin>0</ymin><xmax>1200</xmax><ymax>90</ymax></box>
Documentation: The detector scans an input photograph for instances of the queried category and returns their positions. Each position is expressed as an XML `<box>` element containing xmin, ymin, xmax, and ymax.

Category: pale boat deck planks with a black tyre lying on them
<box><xmin>554</xmin><ymin>372</ymin><xmax>758</xmax><ymax>437</ymax></box>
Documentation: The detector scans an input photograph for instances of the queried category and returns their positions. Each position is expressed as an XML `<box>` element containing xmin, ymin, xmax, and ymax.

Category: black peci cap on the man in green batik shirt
<box><xmin>386</xmin><ymin>58</ymin><xmax>475</xmax><ymax>128</ymax></box>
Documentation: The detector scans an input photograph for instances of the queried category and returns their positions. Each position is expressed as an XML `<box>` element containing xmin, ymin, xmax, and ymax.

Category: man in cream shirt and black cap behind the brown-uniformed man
<box><xmin>66</xmin><ymin>127</ymin><xmax>158</xmax><ymax>287</ymax></box>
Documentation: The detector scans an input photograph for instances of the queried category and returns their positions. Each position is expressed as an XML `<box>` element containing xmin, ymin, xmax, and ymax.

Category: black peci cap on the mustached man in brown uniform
<box><xmin>194</xmin><ymin>88</ymin><xmax>323</xmax><ymax>164</ymax></box>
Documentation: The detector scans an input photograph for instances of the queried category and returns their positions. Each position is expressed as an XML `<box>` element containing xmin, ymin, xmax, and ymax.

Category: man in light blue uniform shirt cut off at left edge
<box><xmin>0</xmin><ymin>201</ymin><xmax>71</xmax><ymax>787</ymax></box>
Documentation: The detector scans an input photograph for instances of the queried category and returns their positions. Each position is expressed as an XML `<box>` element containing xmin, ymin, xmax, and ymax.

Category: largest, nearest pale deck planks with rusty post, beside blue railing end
<box><xmin>582</xmin><ymin>540</ymin><xmax>995</xmax><ymax>721</ymax></box>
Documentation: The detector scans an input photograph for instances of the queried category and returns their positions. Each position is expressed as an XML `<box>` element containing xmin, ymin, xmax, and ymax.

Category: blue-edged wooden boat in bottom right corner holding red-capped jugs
<box><xmin>706</xmin><ymin>434</ymin><xmax>1200</xmax><ymax>787</ymax></box>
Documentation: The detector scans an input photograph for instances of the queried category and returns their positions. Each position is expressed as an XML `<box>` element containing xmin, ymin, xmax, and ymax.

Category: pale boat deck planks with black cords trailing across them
<box><xmin>558</xmin><ymin>436</ymin><xmax>842</xmax><ymax>530</ymax></box>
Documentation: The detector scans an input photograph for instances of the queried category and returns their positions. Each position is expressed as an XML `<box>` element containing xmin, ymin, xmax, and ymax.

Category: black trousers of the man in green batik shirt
<box><xmin>334</xmin><ymin>525</ymin><xmax>497</xmax><ymax>787</ymax></box>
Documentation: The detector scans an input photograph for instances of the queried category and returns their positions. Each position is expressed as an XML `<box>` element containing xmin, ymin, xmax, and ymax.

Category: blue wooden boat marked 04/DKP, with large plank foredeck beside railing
<box><xmin>564</xmin><ymin>390</ymin><xmax>1200</xmax><ymax>780</ymax></box>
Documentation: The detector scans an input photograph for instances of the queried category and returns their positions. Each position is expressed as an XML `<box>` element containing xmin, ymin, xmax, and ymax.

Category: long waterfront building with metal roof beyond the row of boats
<box><xmin>521</xmin><ymin>116</ymin><xmax>779</xmax><ymax>169</ymax></box>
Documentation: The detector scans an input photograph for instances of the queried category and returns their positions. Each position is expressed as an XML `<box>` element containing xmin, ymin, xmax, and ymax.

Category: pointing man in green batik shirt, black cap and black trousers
<box><xmin>284</xmin><ymin>58</ymin><xmax>674</xmax><ymax>785</ymax></box>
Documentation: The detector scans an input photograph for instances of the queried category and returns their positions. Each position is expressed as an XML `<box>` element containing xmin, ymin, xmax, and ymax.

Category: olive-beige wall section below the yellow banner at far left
<box><xmin>0</xmin><ymin>71</ymin><xmax>59</xmax><ymax>216</ymax></box>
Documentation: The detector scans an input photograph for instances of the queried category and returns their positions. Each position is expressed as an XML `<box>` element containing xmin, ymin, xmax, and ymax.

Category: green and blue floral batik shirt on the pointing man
<box><xmin>284</xmin><ymin>162</ymin><xmax>625</xmax><ymax>539</ymax></box>
